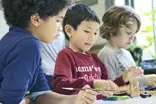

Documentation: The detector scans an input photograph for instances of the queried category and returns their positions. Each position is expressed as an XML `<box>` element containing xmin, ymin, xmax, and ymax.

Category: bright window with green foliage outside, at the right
<box><xmin>134</xmin><ymin>0</ymin><xmax>156</xmax><ymax>60</ymax></box>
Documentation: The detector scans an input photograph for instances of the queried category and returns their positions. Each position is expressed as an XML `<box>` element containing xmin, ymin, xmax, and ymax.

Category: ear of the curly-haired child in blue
<box><xmin>30</xmin><ymin>14</ymin><xmax>41</xmax><ymax>27</ymax></box>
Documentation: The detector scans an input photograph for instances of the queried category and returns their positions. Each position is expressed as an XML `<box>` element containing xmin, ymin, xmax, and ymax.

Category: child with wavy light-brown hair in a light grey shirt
<box><xmin>99</xmin><ymin>6</ymin><xmax>156</xmax><ymax>88</ymax></box>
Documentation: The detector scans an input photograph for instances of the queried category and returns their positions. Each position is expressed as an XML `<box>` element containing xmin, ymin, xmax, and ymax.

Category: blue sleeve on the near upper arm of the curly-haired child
<box><xmin>0</xmin><ymin>39</ymin><xmax>45</xmax><ymax>104</ymax></box>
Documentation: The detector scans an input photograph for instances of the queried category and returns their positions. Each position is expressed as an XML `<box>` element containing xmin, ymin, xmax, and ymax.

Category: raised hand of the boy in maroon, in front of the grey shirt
<box><xmin>122</xmin><ymin>67</ymin><xmax>144</xmax><ymax>82</ymax></box>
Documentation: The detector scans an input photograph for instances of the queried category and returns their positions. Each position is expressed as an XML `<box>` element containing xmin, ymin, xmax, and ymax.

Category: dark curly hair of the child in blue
<box><xmin>2</xmin><ymin>0</ymin><xmax>70</xmax><ymax>28</ymax></box>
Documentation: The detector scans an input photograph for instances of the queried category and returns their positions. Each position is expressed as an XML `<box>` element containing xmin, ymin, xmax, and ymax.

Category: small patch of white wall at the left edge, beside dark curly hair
<box><xmin>0</xmin><ymin>10</ymin><xmax>9</xmax><ymax>39</ymax></box>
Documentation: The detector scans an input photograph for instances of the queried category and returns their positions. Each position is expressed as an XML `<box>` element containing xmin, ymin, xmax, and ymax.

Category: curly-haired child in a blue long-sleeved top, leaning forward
<box><xmin>0</xmin><ymin>0</ymin><xmax>96</xmax><ymax>104</ymax></box>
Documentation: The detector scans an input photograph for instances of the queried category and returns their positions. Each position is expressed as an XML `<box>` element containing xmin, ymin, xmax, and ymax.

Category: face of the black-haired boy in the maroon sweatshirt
<box><xmin>69</xmin><ymin>21</ymin><xmax>100</xmax><ymax>52</ymax></box>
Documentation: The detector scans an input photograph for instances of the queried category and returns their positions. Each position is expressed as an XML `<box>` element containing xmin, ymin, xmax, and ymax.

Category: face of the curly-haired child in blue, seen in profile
<box><xmin>29</xmin><ymin>9</ymin><xmax>66</xmax><ymax>43</ymax></box>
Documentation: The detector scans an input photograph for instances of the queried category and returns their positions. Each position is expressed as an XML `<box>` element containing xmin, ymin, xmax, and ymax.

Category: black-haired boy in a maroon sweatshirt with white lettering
<box><xmin>53</xmin><ymin>4</ymin><xmax>141</xmax><ymax>95</ymax></box>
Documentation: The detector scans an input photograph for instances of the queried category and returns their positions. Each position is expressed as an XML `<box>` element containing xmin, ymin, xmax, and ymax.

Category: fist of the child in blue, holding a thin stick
<box><xmin>75</xmin><ymin>85</ymin><xmax>97</xmax><ymax>104</ymax></box>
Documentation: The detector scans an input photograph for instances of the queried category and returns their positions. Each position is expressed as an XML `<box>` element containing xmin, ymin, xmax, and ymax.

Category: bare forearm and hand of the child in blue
<box><xmin>35</xmin><ymin>86</ymin><xmax>97</xmax><ymax>104</ymax></box>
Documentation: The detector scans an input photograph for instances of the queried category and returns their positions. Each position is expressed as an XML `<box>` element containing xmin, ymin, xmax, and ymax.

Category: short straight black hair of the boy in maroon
<box><xmin>63</xmin><ymin>4</ymin><xmax>100</xmax><ymax>40</ymax></box>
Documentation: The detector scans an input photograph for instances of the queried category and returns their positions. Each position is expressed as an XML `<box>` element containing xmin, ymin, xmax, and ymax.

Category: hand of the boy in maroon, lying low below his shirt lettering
<box><xmin>94</xmin><ymin>80</ymin><xmax>119</xmax><ymax>91</ymax></box>
